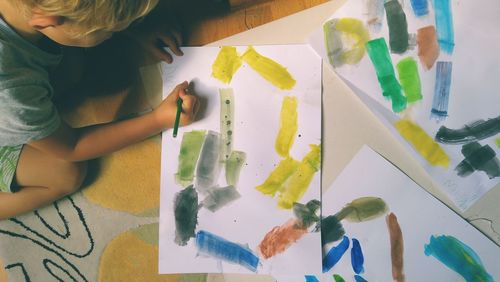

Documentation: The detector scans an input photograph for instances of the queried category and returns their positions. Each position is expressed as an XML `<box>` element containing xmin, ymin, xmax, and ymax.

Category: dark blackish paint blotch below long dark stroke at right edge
<box><xmin>455</xmin><ymin>142</ymin><xmax>500</xmax><ymax>179</ymax></box>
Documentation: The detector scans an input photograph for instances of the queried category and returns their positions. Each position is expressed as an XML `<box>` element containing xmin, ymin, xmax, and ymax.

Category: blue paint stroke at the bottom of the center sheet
<box><xmin>196</xmin><ymin>230</ymin><xmax>259</xmax><ymax>272</ymax></box>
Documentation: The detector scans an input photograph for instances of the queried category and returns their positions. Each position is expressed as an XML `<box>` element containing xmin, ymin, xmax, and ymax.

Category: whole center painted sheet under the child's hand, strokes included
<box><xmin>159</xmin><ymin>45</ymin><xmax>321</xmax><ymax>274</ymax></box>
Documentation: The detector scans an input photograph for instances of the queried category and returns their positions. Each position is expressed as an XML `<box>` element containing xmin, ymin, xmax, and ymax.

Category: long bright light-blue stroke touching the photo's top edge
<box><xmin>434</xmin><ymin>0</ymin><xmax>455</xmax><ymax>54</ymax></box>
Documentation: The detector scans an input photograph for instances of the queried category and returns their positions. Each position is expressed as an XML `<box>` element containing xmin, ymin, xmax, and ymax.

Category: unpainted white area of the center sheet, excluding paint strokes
<box><xmin>159</xmin><ymin>45</ymin><xmax>321</xmax><ymax>274</ymax></box>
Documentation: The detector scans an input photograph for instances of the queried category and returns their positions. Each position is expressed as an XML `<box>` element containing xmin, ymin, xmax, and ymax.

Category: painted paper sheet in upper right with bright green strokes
<box><xmin>310</xmin><ymin>0</ymin><xmax>500</xmax><ymax>210</ymax></box>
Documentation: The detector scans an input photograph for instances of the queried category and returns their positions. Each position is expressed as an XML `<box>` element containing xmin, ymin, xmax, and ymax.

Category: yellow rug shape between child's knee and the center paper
<box><xmin>83</xmin><ymin>138</ymin><xmax>161</xmax><ymax>215</ymax></box>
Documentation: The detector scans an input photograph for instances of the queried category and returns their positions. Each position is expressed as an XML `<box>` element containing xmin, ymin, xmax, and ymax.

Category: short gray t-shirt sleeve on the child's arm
<box><xmin>0</xmin><ymin>85</ymin><xmax>61</xmax><ymax>146</ymax></box>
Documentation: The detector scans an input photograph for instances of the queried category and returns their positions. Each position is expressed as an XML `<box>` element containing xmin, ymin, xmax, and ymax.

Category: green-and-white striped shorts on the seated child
<box><xmin>0</xmin><ymin>145</ymin><xmax>23</xmax><ymax>193</ymax></box>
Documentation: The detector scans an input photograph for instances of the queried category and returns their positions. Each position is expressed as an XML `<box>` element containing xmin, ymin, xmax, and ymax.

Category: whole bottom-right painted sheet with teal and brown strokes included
<box><xmin>275</xmin><ymin>146</ymin><xmax>500</xmax><ymax>282</ymax></box>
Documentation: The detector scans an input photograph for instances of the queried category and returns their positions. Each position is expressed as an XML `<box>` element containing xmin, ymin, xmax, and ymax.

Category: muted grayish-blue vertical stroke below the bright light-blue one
<box><xmin>431</xmin><ymin>62</ymin><xmax>452</xmax><ymax>121</ymax></box>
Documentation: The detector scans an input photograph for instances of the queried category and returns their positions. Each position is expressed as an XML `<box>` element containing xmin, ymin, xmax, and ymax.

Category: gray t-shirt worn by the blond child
<box><xmin>0</xmin><ymin>18</ymin><xmax>61</xmax><ymax>146</ymax></box>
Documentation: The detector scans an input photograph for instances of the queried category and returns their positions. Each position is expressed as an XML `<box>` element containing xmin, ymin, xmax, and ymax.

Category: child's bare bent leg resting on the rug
<box><xmin>0</xmin><ymin>145</ymin><xmax>87</xmax><ymax>219</ymax></box>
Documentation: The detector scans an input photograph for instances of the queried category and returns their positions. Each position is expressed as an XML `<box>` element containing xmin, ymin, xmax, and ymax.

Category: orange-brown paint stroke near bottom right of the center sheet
<box><xmin>258</xmin><ymin>219</ymin><xmax>307</xmax><ymax>259</ymax></box>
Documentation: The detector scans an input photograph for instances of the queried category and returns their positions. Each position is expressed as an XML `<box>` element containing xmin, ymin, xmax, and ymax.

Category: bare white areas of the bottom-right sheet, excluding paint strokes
<box><xmin>275</xmin><ymin>146</ymin><xmax>500</xmax><ymax>282</ymax></box>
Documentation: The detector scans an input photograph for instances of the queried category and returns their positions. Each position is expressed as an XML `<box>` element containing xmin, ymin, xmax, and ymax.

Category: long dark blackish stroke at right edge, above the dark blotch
<box><xmin>436</xmin><ymin>116</ymin><xmax>500</xmax><ymax>144</ymax></box>
